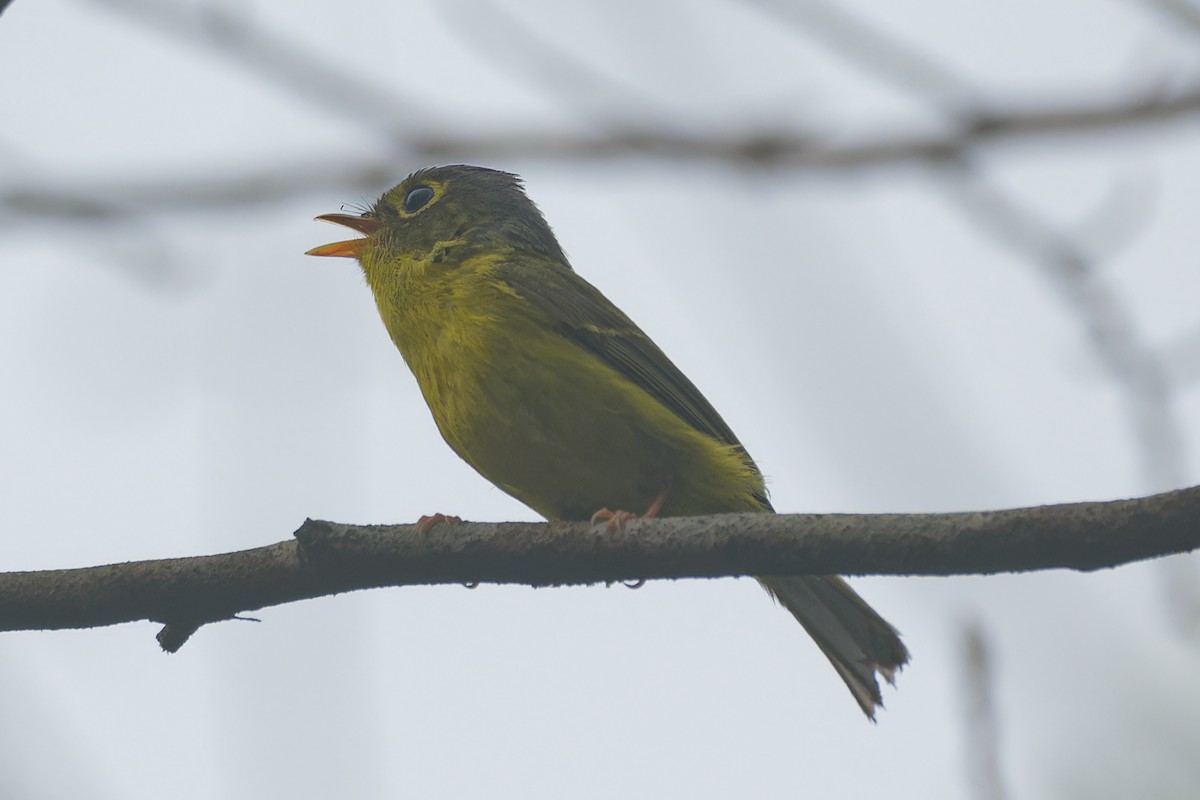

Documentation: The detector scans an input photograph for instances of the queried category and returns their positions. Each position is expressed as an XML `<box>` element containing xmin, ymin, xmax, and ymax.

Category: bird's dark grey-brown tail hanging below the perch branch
<box><xmin>758</xmin><ymin>576</ymin><xmax>908</xmax><ymax>721</ymax></box>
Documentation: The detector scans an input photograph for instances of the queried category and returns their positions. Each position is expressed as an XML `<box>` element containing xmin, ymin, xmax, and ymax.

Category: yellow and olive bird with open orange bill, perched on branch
<box><xmin>308</xmin><ymin>164</ymin><xmax>908</xmax><ymax>721</ymax></box>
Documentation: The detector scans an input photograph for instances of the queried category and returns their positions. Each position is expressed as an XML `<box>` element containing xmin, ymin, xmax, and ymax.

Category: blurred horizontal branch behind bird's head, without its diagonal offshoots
<box><xmin>9</xmin><ymin>78</ymin><xmax>1200</xmax><ymax>223</ymax></box>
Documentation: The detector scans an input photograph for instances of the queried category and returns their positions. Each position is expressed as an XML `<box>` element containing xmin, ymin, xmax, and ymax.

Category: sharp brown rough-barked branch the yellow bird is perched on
<box><xmin>0</xmin><ymin>487</ymin><xmax>1200</xmax><ymax>651</ymax></box>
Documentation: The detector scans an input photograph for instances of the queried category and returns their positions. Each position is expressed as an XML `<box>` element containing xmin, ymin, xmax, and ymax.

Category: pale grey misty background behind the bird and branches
<box><xmin>0</xmin><ymin>0</ymin><xmax>1200</xmax><ymax>800</ymax></box>
